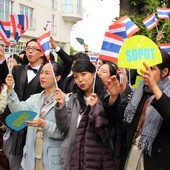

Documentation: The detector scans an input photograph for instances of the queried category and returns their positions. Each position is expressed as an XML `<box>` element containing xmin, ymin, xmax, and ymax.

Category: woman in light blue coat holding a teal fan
<box><xmin>6</xmin><ymin>62</ymin><xmax>64</xmax><ymax>170</ymax></box>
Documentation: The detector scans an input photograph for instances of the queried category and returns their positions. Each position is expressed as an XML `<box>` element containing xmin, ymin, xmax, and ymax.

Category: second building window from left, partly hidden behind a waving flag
<box><xmin>20</xmin><ymin>4</ymin><xmax>35</xmax><ymax>30</ymax></box>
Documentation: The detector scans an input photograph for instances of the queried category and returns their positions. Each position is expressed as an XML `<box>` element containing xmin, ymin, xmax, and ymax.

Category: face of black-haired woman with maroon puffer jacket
<box><xmin>73</xmin><ymin>71</ymin><xmax>94</xmax><ymax>94</ymax></box>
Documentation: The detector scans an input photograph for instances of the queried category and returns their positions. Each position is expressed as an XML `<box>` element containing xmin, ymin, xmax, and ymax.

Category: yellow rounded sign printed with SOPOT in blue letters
<box><xmin>118</xmin><ymin>35</ymin><xmax>162</xmax><ymax>70</ymax></box>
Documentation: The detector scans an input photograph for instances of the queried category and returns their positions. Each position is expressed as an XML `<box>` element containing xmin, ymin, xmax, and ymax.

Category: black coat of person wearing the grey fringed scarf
<box><xmin>120</xmin><ymin>94</ymin><xmax>170</xmax><ymax>170</ymax></box>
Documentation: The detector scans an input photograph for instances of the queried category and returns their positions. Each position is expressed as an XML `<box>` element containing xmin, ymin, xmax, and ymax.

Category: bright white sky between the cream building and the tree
<box><xmin>70</xmin><ymin>0</ymin><xmax>119</xmax><ymax>52</ymax></box>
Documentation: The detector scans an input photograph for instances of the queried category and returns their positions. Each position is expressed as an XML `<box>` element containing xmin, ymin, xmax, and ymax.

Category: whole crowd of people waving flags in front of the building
<box><xmin>0</xmin><ymin>37</ymin><xmax>170</xmax><ymax>170</ymax></box>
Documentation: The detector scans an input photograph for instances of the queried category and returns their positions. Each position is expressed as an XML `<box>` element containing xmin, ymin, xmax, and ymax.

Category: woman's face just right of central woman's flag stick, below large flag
<box><xmin>98</xmin><ymin>64</ymin><xmax>110</xmax><ymax>82</ymax></box>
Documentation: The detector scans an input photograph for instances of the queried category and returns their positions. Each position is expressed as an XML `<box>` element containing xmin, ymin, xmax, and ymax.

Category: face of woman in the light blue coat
<box><xmin>39</xmin><ymin>63</ymin><xmax>55</xmax><ymax>89</ymax></box>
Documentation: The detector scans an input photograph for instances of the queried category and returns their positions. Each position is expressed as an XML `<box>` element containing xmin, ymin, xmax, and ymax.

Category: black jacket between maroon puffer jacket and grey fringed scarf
<box><xmin>104</xmin><ymin>85</ymin><xmax>131</xmax><ymax>170</ymax></box>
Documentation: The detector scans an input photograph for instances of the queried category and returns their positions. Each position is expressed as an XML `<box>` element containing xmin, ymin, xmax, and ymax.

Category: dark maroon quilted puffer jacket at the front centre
<box><xmin>70</xmin><ymin>102</ymin><xmax>115</xmax><ymax>170</ymax></box>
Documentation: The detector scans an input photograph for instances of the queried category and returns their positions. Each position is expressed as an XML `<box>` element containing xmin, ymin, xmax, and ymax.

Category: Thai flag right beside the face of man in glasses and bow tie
<box><xmin>37</xmin><ymin>31</ymin><xmax>50</xmax><ymax>60</ymax></box>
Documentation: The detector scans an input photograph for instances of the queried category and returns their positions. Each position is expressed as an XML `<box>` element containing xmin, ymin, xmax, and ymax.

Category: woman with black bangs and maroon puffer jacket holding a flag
<box><xmin>55</xmin><ymin>60</ymin><xmax>115</xmax><ymax>170</ymax></box>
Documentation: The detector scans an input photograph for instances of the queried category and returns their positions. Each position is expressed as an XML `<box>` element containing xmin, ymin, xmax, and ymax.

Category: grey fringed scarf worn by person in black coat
<box><xmin>124</xmin><ymin>77</ymin><xmax>170</xmax><ymax>156</ymax></box>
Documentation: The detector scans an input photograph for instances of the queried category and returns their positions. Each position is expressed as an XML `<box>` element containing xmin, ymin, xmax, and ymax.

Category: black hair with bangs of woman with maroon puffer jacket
<box><xmin>72</xmin><ymin>60</ymin><xmax>104</xmax><ymax>112</ymax></box>
